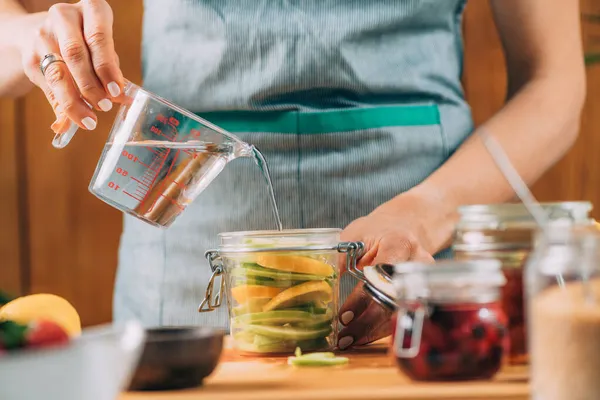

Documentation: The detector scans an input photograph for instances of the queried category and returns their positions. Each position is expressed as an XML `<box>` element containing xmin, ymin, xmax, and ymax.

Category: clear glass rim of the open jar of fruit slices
<box><xmin>219</xmin><ymin>228</ymin><xmax>341</xmax><ymax>253</ymax></box>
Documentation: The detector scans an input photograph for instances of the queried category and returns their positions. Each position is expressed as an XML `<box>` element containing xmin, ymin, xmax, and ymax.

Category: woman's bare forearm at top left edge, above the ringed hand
<box><xmin>0</xmin><ymin>0</ymin><xmax>45</xmax><ymax>97</ymax></box>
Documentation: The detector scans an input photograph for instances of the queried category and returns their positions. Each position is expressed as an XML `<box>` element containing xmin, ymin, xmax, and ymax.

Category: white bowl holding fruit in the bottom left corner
<box><xmin>0</xmin><ymin>321</ymin><xmax>146</xmax><ymax>400</ymax></box>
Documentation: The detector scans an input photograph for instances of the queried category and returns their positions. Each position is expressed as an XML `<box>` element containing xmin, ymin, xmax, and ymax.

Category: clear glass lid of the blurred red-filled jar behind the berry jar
<box><xmin>458</xmin><ymin>201</ymin><xmax>593</xmax><ymax>228</ymax></box>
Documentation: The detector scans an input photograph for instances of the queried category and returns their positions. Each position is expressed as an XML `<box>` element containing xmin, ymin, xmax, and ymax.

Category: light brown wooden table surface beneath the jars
<box><xmin>120</xmin><ymin>343</ymin><xmax>529</xmax><ymax>400</ymax></box>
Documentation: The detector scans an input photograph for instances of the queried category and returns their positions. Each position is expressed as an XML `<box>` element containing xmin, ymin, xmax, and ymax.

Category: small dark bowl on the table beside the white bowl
<box><xmin>129</xmin><ymin>327</ymin><xmax>225</xmax><ymax>391</ymax></box>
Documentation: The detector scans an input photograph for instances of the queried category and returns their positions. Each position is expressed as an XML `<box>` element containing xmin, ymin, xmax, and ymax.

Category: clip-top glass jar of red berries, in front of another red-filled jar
<box><xmin>393</xmin><ymin>260</ymin><xmax>509</xmax><ymax>381</ymax></box>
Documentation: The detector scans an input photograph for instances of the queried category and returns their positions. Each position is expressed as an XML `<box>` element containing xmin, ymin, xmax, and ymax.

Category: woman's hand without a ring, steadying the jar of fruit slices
<box><xmin>338</xmin><ymin>192</ymin><xmax>451</xmax><ymax>350</ymax></box>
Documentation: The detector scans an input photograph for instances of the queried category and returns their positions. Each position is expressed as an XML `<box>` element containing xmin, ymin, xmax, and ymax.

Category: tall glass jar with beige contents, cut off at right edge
<box><xmin>525</xmin><ymin>228</ymin><xmax>600</xmax><ymax>400</ymax></box>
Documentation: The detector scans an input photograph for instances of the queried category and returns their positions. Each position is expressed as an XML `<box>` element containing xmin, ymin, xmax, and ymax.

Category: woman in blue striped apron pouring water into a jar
<box><xmin>0</xmin><ymin>0</ymin><xmax>585</xmax><ymax>348</ymax></box>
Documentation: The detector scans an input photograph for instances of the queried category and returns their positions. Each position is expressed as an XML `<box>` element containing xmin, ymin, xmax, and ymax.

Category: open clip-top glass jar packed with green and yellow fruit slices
<box><xmin>200</xmin><ymin>229</ymin><xmax>362</xmax><ymax>354</ymax></box>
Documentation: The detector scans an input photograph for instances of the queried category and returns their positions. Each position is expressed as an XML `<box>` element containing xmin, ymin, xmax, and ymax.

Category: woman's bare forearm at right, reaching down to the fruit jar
<box><xmin>392</xmin><ymin>73</ymin><xmax>585</xmax><ymax>252</ymax></box>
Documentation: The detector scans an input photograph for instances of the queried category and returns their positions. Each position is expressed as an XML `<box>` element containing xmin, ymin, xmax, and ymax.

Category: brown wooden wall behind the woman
<box><xmin>0</xmin><ymin>0</ymin><xmax>600</xmax><ymax>325</ymax></box>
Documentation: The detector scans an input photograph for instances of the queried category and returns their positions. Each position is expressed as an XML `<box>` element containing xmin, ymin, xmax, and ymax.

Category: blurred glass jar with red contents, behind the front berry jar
<box><xmin>452</xmin><ymin>202</ymin><xmax>593</xmax><ymax>365</ymax></box>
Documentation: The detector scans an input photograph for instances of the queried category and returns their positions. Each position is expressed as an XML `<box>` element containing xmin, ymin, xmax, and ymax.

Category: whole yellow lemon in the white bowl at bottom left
<box><xmin>0</xmin><ymin>294</ymin><xmax>81</xmax><ymax>336</ymax></box>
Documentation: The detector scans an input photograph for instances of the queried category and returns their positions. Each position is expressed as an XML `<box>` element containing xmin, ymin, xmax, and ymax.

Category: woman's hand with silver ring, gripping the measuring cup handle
<box><xmin>21</xmin><ymin>0</ymin><xmax>124</xmax><ymax>133</ymax></box>
